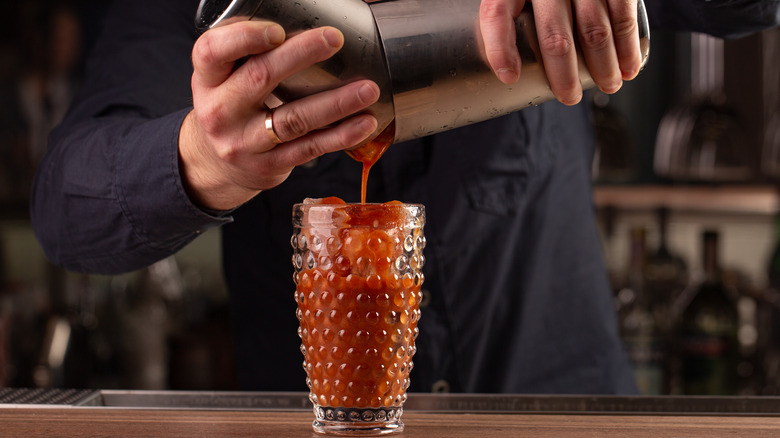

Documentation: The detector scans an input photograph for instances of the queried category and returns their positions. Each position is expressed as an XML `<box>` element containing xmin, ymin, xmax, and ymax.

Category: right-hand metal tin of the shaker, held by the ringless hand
<box><xmin>371</xmin><ymin>0</ymin><xmax>649</xmax><ymax>142</ymax></box>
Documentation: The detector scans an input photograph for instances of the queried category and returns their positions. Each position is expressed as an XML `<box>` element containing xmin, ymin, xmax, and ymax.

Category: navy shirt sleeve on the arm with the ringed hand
<box><xmin>31</xmin><ymin>0</ymin><xmax>231</xmax><ymax>274</ymax></box>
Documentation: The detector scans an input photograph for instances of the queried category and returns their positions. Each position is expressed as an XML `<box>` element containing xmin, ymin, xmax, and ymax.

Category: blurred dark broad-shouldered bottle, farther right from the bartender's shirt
<box><xmin>679</xmin><ymin>230</ymin><xmax>739</xmax><ymax>395</ymax></box>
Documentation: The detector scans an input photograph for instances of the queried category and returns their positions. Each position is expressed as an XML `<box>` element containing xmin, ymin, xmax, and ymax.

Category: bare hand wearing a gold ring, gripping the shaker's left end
<box><xmin>179</xmin><ymin>21</ymin><xmax>379</xmax><ymax>210</ymax></box>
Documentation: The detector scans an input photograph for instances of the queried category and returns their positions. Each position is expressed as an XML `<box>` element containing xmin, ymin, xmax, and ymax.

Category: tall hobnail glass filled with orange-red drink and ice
<box><xmin>291</xmin><ymin>202</ymin><xmax>425</xmax><ymax>435</ymax></box>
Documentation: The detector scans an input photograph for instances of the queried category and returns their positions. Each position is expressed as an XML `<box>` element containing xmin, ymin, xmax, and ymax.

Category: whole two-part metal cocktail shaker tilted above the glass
<box><xmin>196</xmin><ymin>0</ymin><xmax>650</xmax><ymax>143</ymax></box>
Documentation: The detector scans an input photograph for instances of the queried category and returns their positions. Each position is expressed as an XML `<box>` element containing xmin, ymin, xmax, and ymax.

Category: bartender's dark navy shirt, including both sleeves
<box><xmin>32</xmin><ymin>0</ymin><xmax>778</xmax><ymax>394</ymax></box>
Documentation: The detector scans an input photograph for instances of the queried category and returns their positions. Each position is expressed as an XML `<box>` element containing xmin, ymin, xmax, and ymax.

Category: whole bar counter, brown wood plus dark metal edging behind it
<box><xmin>0</xmin><ymin>389</ymin><xmax>780</xmax><ymax>438</ymax></box>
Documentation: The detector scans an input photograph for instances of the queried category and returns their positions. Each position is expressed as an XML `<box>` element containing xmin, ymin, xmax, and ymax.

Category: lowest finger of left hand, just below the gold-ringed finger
<box><xmin>257</xmin><ymin>114</ymin><xmax>377</xmax><ymax>169</ymax></box>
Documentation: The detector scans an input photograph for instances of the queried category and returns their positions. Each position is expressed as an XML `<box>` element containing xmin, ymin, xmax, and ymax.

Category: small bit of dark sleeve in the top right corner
<box><xmin>645</xmin><ymin>0</ymin><xmax>780</xmax><ymax>38</ymax></box>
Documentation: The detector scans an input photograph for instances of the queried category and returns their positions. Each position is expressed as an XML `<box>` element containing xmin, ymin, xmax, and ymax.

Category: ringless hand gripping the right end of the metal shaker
<box><xmin>479</xmin><ymin>0</ymin><xmax>642</xmax><ymax>105</ymax></box>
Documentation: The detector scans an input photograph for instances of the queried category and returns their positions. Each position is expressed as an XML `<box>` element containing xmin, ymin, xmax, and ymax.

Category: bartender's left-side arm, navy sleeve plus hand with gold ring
<box><xmin>31</xmin><ymin>0</ymin><xmax>378</xmax><ymax>274</ymax></box>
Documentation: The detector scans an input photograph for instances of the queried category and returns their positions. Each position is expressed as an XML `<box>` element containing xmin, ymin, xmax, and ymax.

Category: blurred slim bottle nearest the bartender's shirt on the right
<box><xmin>618</xmin><ymin>227</ymin><xmax>665</xmax><ymax>395</ymax></box>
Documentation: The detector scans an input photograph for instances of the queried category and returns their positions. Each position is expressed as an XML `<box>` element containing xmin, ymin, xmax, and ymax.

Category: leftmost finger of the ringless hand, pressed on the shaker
<box><xmin>479</xmin><ymin>0</ymin><xmax>525</xmax><ymax>84</ymax></box>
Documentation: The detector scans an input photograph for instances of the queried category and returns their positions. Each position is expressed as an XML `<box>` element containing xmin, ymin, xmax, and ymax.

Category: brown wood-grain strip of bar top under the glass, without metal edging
<box><xmin>0</xmin><ymin>407</ymin><xmax>780</xmax><ymax>438</ymax></box>
